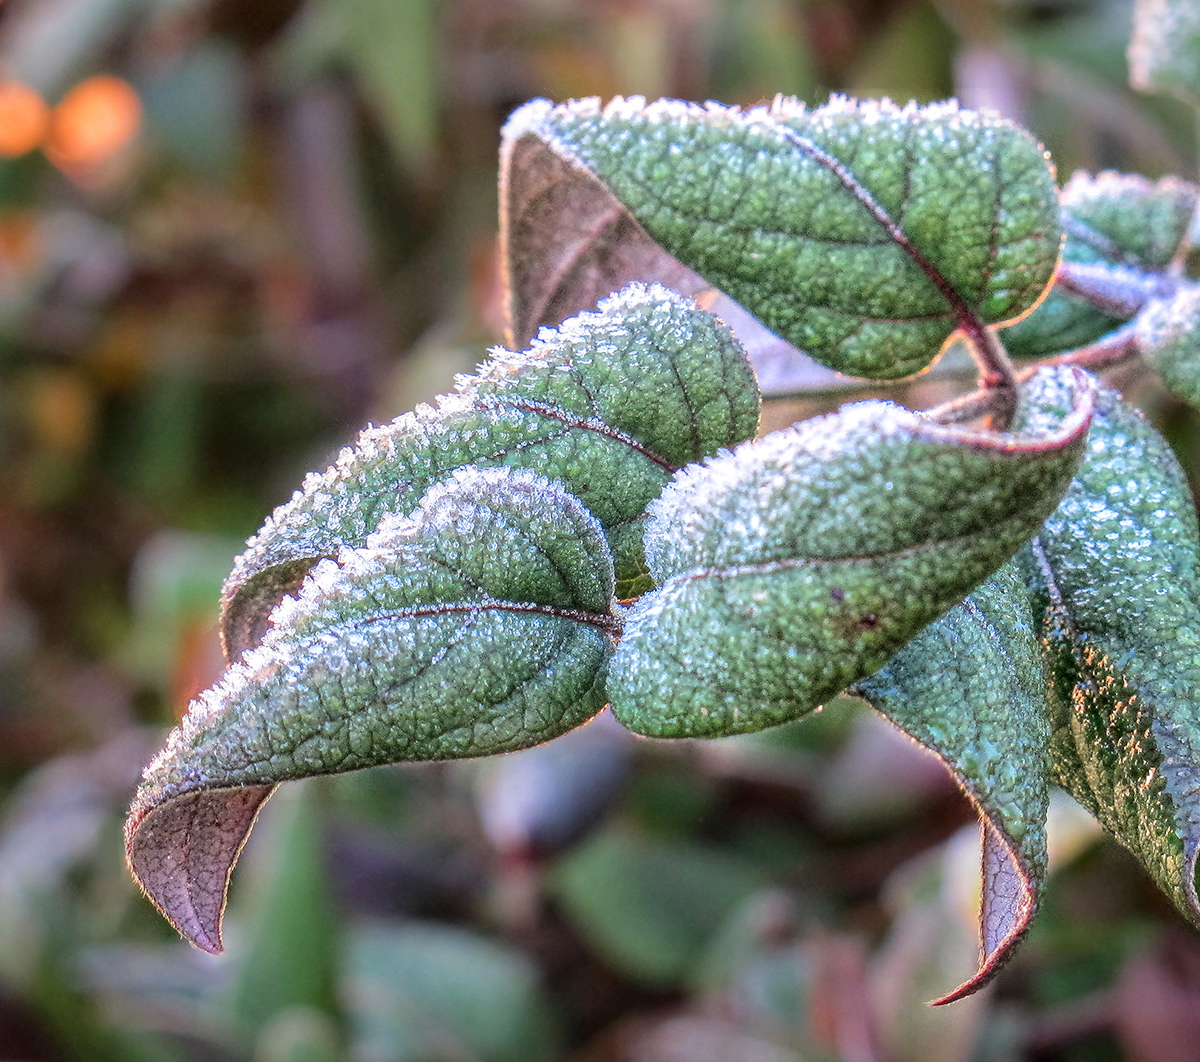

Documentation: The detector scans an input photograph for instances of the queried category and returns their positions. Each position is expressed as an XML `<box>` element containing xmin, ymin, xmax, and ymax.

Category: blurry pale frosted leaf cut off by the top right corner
<box><xmin>1129</xmin><ymin>0</ymin><xmax>1200</xmax><ymax>107</ymax></box>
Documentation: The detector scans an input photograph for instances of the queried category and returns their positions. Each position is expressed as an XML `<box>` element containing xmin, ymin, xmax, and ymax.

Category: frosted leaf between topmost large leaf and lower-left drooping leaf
<box><xmin>222</xmin><ymin>284</ymin><xmax>758</xmax><ymax>659</ymax></box>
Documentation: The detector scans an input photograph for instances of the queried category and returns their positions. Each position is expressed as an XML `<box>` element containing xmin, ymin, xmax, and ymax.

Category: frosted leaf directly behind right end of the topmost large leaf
<box><xmin>1003</xmin><ymin>172</ymin><xmax>1200</xmax><ymax>356</ymax></box>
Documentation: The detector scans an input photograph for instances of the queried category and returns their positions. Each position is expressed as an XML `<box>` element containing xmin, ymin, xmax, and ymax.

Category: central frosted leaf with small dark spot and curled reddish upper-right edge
<box><xmin>608</xmin><ymin>373</ymin><xmax>1091</xmax><ymax>737</ymax></box>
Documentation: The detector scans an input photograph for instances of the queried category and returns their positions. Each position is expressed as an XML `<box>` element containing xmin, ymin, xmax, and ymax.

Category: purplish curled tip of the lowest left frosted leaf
<box><xmin>125</xmin><ymin>785</ymin><xmax>275</xmax><ymax>955</ymax></box>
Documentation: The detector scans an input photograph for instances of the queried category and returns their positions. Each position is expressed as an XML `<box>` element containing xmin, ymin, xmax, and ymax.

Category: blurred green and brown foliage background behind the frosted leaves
<box><xmin>0</xmin><ymin>0</ymin><xmax>1200</xmax><ymax>1062</ymax></box>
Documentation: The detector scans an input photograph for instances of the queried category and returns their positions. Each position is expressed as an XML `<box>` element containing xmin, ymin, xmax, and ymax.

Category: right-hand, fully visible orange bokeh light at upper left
<box><xmin>46</xmin><ymin>74</ymin><xmax>142</xmax><ymax>172</ymax></box>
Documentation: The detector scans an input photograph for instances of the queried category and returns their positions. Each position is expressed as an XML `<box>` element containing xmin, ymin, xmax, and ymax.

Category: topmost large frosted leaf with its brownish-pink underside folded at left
<box><xmin>502</xmin><ymin>97</ymin><xmax>1061</xmax><ymax>378</ymax></box>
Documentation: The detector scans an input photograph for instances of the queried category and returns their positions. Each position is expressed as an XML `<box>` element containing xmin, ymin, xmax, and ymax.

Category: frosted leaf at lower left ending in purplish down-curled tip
<box><xmin>126</xmin><ymin>468</ymin><xmax>620</xmax><ymax>950</ymax></box>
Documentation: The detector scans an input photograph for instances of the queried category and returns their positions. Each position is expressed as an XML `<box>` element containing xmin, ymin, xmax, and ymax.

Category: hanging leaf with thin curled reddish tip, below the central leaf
<box><xmin>854</xmin><ymin>564</ymin><xmax>1050</xmax><ymax>1003</ymax></box>
